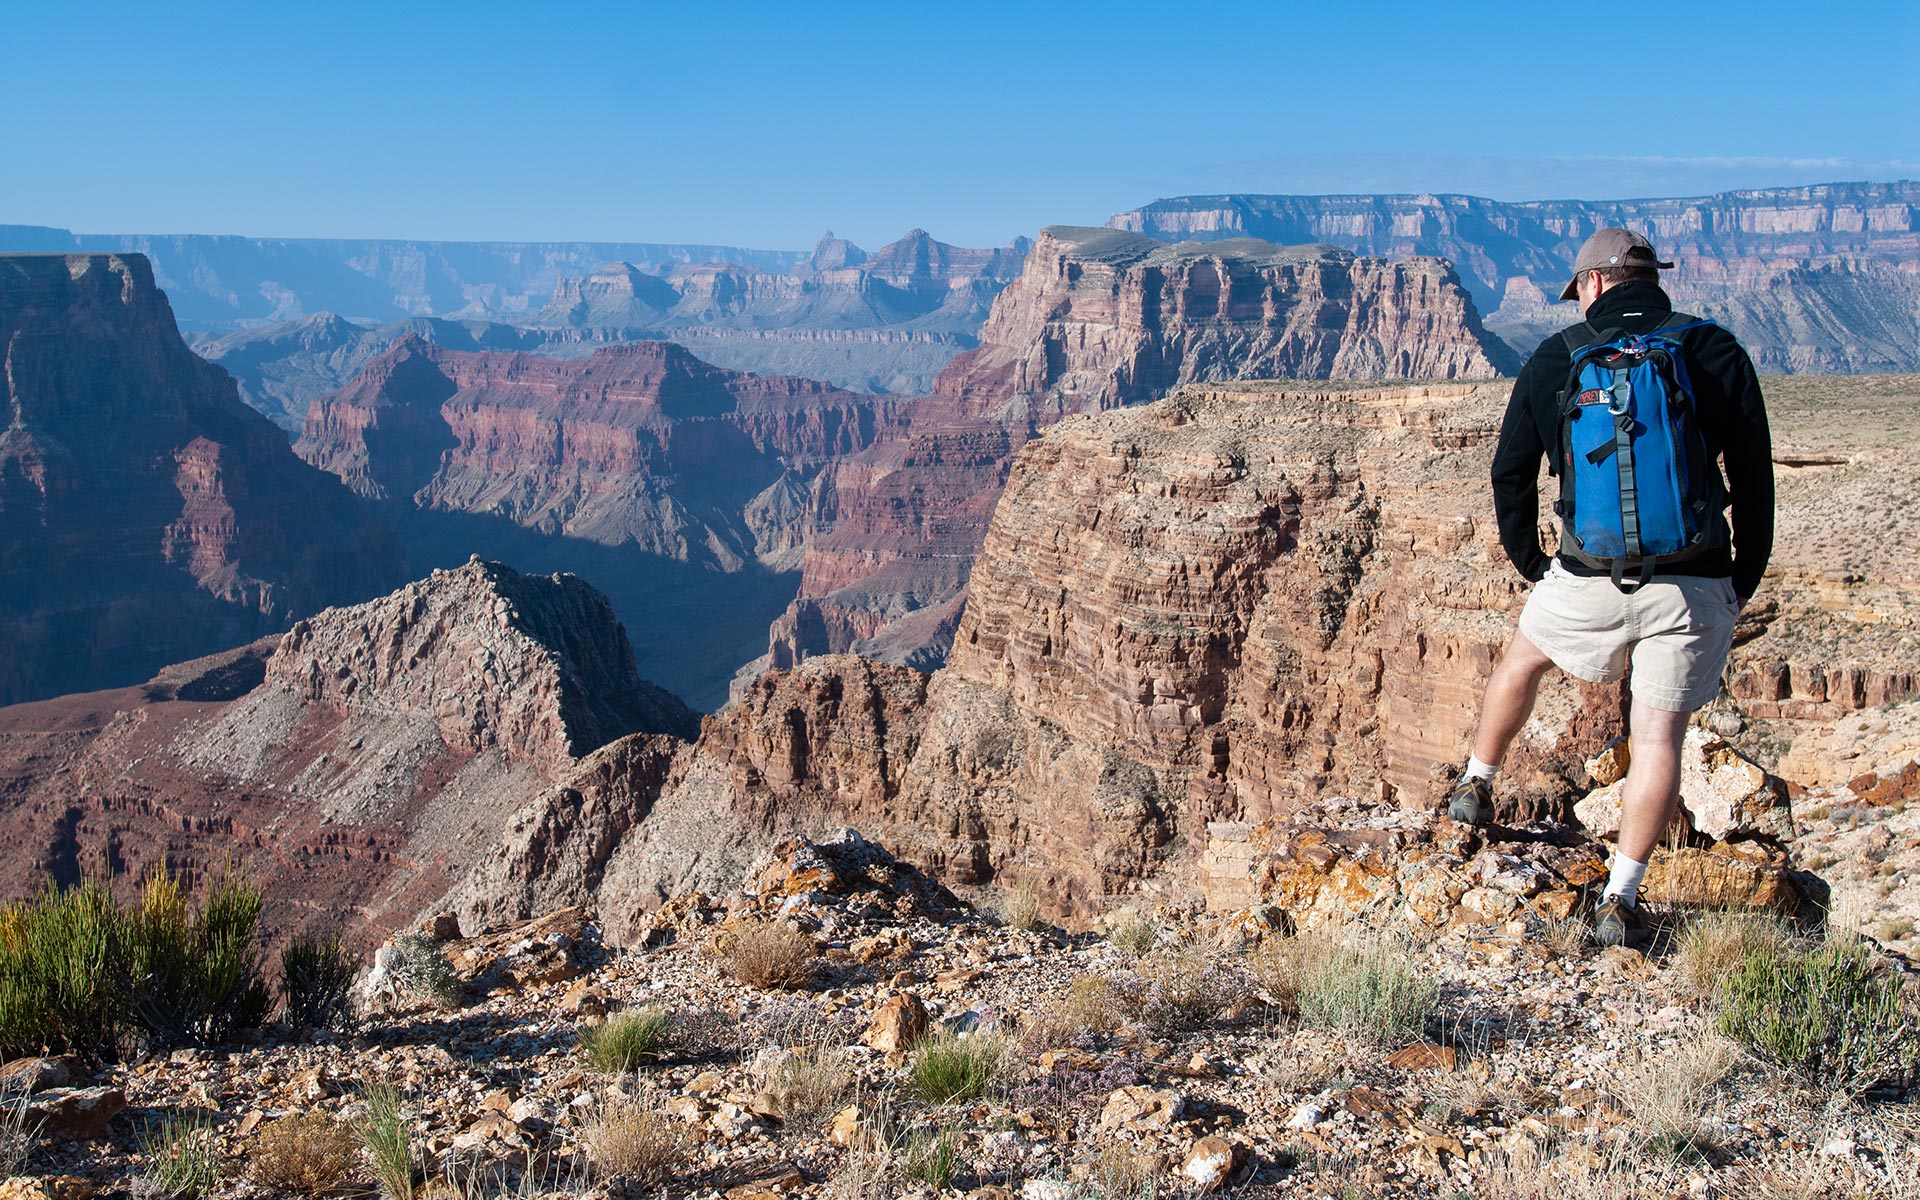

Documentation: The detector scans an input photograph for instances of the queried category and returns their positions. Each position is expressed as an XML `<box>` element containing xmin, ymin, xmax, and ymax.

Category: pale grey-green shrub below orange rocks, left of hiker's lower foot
<box><xmin>1252</xmin><ymin>933</ymin><xmax>1440</xmax><ymax>1044</ymax></box>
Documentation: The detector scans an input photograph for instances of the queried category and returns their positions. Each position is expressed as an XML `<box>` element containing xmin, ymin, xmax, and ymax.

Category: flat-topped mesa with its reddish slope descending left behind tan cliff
<box><xmin>770</xmin><ymin>227</ymin><xmax>1515</xmax><ymax>666</ymax></box>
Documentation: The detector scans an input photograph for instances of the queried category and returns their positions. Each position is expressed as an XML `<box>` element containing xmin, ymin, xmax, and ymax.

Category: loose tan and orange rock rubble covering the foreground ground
<box><xmin>0</xmin><ymin>821</ymin><xmax>1920</xmax><ymax>1200</ymax></box>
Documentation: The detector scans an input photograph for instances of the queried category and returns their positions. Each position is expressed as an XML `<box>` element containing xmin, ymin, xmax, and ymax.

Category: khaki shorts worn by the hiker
<box><xmin>1521</xmin><ymin>559</ymin><xmax>1740</xmax><ymax>712</ymax></box>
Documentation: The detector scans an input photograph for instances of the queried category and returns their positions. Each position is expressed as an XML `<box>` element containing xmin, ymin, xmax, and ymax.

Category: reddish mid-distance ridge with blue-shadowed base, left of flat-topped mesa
<box><xmin>298</xmin><ymin>338</ymin><xmax>899</xmax><ymax>705</ymax></box>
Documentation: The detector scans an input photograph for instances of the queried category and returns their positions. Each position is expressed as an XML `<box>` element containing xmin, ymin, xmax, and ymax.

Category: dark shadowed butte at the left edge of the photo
<box><xmin>0</xmin><ymin>255</ymin><xmax>403</xmax><ymax>705</ymax></box>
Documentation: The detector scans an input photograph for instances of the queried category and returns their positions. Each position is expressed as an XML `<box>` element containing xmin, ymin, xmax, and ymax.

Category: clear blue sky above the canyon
<box><xmin>0</xmin><ymin>0</ymin><xmax>1920</xmax><ymax>248</ymax></box>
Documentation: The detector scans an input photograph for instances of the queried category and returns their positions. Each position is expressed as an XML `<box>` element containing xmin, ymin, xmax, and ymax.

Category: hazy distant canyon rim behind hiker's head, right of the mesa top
<box><xmin>1108</xmin><ymin>182</ymin><xmax>1920</xmax><ymax>372</ymax></box>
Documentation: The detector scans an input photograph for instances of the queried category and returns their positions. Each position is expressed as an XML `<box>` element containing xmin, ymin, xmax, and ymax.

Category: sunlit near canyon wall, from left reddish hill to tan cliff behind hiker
<box><xmin>11</xmin><ymin>376</ymin><xmax>1920</xmax><ymax>941</ymax></box>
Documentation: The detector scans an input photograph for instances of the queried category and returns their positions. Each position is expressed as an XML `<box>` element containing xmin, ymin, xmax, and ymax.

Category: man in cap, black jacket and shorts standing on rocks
<box><xmin>1448</xmin><ymin>228</ymin><xmax>1774</xmax><ymax>945</ymax></box>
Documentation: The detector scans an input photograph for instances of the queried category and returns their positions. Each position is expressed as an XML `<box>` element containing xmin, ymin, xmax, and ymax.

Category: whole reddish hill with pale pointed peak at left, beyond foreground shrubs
<box><xmin>0</xmin><ymin>563</ymin><xmax>697</xmax><ymax>937</ymax></box>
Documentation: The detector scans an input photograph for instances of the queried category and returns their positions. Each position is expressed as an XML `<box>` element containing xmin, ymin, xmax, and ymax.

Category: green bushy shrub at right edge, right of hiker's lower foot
<box><xmin>1715</xmin><ymin>939</ymin><xmax>1920</xmax><ymax>1094</ymax></box>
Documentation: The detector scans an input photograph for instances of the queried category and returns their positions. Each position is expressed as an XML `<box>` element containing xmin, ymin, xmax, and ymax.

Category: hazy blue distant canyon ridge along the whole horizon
<box><xmin>0</xmin><ymin>182</ymin><xmax>1920</xmax><ymax>424</ymax></box>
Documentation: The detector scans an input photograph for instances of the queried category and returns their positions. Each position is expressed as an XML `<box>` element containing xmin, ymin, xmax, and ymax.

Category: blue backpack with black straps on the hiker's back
<box><xmin>1553</xmin><ymin>313</ymin><xmax>1726</xmax><ymax>591</ymax></box>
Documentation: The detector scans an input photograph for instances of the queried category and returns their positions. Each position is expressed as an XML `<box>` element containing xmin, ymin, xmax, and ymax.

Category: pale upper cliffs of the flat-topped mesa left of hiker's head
<box><xmin>935</xmin><ymin>227</ymin><xmax>1517</xmax><ymax>420</ymax></box>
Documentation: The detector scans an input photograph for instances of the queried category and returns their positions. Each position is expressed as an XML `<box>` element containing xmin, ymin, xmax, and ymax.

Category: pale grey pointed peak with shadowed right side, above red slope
<box><xmin>267</xmin><ymin>559</ymin><xmax>699</xmax><ymax>768</ymax></box>
